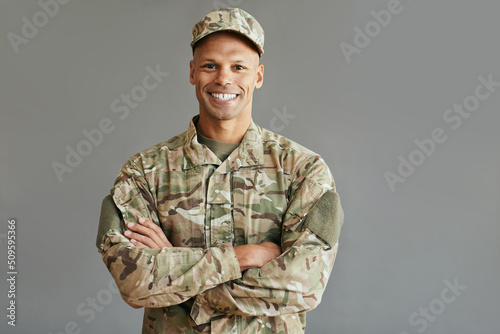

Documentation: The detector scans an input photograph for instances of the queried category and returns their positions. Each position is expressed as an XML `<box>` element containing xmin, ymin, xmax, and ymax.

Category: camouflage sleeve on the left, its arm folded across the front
<box><xmin>97</xmin><ymin>161</ymin><xmax>241</xmax><ymax>308</ymax></box>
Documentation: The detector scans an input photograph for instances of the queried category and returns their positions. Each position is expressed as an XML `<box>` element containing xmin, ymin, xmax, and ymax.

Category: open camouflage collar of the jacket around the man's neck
<box><xmin>183</xmin><ymin>115</ymin><xmax>264</xmax><ymax>172</ymax></box>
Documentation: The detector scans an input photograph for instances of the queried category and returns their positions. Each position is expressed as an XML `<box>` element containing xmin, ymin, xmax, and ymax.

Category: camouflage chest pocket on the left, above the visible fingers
<box><xmin>157</xmin><ymin>169</ymin><xmax>205</xmax><ymax>247</ymax></box>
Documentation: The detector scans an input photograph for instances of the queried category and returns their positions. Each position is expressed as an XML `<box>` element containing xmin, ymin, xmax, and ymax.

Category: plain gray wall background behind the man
<box><xmin>0</xmin><ymin>0</ymin><xmax>500</xmax><ymax>334</ymax></box>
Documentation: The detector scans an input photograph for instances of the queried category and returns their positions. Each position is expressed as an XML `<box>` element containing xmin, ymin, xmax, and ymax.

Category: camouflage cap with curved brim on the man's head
<box><xmin>191</xmin><ymin>8</ymin><xmax>264</xmax><ymax>56</ymax></box>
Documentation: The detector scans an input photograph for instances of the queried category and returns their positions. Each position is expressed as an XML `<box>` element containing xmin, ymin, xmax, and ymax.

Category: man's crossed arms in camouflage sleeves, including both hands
<box><xmin>97</xmin><ymin>156</ymin><xmax>343</xmax><ymax>324</ymax></box>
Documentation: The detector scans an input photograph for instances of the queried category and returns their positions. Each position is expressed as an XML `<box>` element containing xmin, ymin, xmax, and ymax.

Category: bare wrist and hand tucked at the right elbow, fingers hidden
<box><xmin>234</xmin><ymin>242</ymin><xmax>281</xmax><ymax>271</ymax></box>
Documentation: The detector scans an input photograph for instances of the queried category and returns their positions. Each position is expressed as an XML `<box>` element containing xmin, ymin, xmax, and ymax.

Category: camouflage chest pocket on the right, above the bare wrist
<box><xmin>232</xmin><ymin>168</ymin><xmax>289</xmax><ymax>246</ymax></box>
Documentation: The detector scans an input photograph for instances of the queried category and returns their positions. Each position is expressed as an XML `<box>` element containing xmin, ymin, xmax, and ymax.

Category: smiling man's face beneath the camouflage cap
<box><xmin>189</xmin><ymin>32</ymin><xmax>264</xmax><ymax>120</ymax></box>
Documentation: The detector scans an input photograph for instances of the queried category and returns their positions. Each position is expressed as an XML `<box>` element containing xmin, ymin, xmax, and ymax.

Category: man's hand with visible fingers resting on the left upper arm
<box><xmin>125</xmin><ymin>218</ymin><xmax>172</xmax><ymax>249</ymax></box>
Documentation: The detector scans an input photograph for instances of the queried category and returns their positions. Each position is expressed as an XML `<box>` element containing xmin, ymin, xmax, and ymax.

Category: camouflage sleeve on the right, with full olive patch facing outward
<box><xmin>191</xmin><ymin>158</ymin><xmax>344</xmax><ymax>324</ymax></box>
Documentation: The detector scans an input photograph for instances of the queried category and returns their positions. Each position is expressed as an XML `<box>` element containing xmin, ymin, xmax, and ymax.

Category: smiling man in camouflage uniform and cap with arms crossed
<box><xmin>97</xmin><ymin>9</ymin><xmax>343</xmax><ymax>333</ymax></box>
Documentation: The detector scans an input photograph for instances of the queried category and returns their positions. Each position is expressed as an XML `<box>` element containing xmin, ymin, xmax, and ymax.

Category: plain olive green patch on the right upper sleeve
<box><xmin>304</xmin><ymin>190</ymin><xmax>344</xmax><ymax>247</ymax></box>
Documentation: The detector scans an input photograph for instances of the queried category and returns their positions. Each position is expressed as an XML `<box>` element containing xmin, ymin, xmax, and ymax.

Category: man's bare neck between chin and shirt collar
<box><xmin>196</xmin><ymin>114</ymin><xmax>252</xmax><ymax>144</ymax></box>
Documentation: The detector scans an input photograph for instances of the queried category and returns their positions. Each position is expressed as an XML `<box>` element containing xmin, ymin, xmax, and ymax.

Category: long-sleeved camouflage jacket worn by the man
<box><xmin>98</xmin><ymin>118</ymin><xmax>343</xmax><ymax>333</ymax></box>
